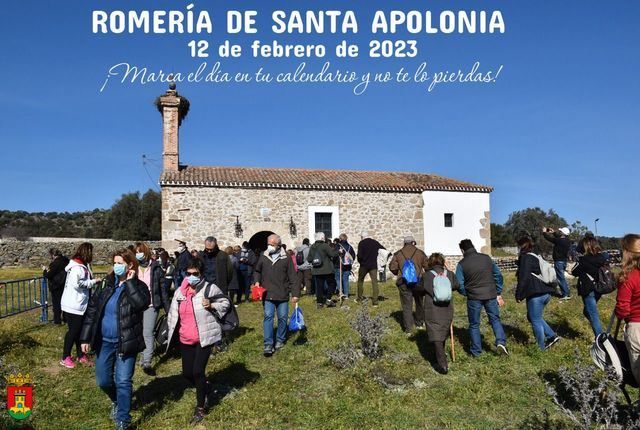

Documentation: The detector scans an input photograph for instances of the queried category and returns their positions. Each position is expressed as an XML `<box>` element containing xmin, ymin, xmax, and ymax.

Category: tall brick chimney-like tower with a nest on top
<box><xmin>156</xmin><ymin>82</ymin><xmax>182</xmax><ymax>172</ymax></box>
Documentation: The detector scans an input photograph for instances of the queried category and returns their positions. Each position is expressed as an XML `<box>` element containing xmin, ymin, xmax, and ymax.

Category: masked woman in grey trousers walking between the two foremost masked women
<box><xmin>135</xmin><ymin>242</ymin><xmax>169</xmax><ymax>376</ymax></box>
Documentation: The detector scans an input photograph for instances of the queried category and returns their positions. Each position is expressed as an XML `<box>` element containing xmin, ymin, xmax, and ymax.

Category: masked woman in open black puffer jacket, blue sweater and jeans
<box><xmin>80</xmin><ymin>249</ymin><xmax>151</xmax><ymax>429</ymax></box>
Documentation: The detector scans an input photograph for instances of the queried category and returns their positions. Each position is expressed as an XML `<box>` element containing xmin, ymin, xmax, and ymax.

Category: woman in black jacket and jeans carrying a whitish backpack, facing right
<box><xmin>516</xmin><ymin>236</ymin><xmax>560</xmax><ymax>350</ymax></box>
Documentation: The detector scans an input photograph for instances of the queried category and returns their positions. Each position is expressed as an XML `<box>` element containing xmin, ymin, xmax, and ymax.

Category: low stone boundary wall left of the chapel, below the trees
<box><xmin>0</xmin><ymin>239</ymin><xmax>160</xmax><ymax>267</ymax></box>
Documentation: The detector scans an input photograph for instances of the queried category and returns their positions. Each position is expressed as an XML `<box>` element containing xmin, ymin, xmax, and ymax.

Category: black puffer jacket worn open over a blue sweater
<box><xmin>80</xmin><ymin>273</ymin><xmax>151</xmax><ymax>355</ymax></box>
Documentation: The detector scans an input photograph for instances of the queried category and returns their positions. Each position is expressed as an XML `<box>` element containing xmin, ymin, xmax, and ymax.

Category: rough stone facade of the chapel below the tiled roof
<box><xmin>162</xmin><ymin>186</ymin><xmax>424</xmax><ymax>250</ymax></box>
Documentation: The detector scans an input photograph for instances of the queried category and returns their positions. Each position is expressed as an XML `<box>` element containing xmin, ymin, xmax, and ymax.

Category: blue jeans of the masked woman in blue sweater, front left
<box><xmin>96</xmin><ymin>341</ymin><xmax>136</xmax><ymax>423</ymax></box>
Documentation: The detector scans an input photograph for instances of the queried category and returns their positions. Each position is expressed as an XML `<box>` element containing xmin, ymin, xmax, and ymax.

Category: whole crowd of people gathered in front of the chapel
<box><xmin>44</xmin><ymin>228</ymin><xmax>640</xmax><ymax>429</ymax></box>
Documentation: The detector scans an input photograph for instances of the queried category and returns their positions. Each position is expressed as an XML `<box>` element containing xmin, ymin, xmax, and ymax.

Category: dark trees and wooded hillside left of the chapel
<box><xmin>0</xmin><ymin>189</ymin><xmax>161</xmax><ymax>240</ymax></box>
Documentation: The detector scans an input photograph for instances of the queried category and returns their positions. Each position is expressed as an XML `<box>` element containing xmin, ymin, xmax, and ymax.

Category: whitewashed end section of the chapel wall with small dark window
<box><xmin>422</xmin><ymin>191</ymin><xmax>489</xmax><ymax>255</ymax></box>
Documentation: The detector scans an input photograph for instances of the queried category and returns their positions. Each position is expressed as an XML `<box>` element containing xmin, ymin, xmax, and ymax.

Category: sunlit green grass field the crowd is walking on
<box><xmin>0</xmin><ymin>274</ymin><xmax>614</xmax><ymax>430</ymax></box>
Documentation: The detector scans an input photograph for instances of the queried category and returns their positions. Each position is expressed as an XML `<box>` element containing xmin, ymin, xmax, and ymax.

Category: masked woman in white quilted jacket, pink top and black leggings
<box><xmin>167</xmin><ymin>258</ymin><xmax>232</xmax><ymax>423</ymax></box>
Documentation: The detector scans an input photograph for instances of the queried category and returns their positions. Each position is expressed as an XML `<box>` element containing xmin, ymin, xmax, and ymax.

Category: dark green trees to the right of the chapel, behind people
<box><xmin>491</xmin><ymin>207</ymin><xmax>620</xmax><ymax>254</ymax></box>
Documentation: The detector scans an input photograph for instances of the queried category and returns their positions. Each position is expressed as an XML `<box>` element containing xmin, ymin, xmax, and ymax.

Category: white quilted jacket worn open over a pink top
<box><xmin>167</xmin><ymin>279</ymin><xmax>233</xmax><ymax>351</ymax></box>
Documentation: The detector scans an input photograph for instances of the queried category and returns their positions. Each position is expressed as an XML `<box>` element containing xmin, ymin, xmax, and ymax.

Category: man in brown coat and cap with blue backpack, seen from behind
<box><xmin>389</xmin><ymin>236</ymin><xmax>429</xmax><ymax>335</ymax></box>
